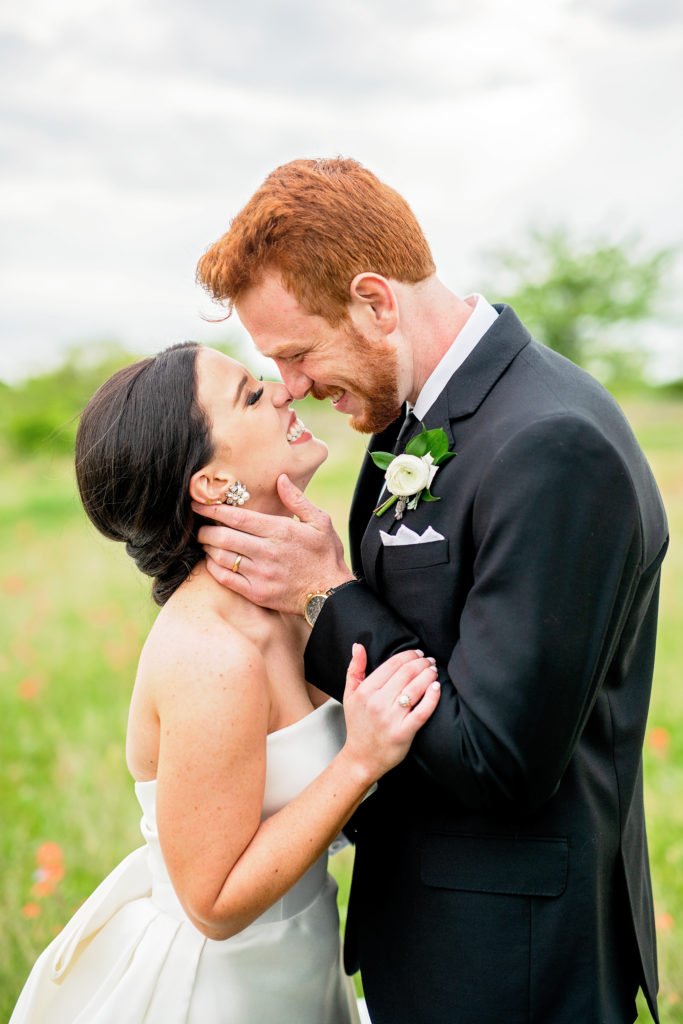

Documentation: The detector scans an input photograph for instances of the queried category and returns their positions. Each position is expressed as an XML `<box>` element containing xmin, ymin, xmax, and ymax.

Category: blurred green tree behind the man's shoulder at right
<box><xmin>488</xmin><ymin>226</ymin><xmax>675</xmax><ymax>385</ymax></box>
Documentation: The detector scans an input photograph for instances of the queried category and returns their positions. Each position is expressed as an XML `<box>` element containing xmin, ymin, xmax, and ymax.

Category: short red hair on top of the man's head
<box><xmin>197</xmin><ymin>157</ymin><xmax>434</xmax><ymax>325</ymax></box>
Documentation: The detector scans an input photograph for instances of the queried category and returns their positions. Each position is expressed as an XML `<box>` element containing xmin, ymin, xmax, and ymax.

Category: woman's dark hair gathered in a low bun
<box><xmin>76</xmin><ymin>342</ymin><xmax>213</xmax><ymax>604</ymax></box>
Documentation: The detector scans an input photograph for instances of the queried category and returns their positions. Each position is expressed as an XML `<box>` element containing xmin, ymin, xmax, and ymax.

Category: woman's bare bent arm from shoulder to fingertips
<box><xmin>156</xmin><ymin>633</ymin><xmax>438</xmax><ymax>939</ymax></box>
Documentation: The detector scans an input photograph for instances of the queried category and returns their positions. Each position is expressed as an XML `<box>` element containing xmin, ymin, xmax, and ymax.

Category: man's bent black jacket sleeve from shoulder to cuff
<box><xmin>305</xmin><ymin>415</ymin><xmax>655</xmax><ymax>812</ymax></box>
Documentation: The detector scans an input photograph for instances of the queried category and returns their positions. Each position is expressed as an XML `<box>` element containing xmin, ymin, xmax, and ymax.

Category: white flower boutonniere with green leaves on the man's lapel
<box><xmin>371</xmin><ymin>424</ymin><xmax>456</xmax><ymax>519</ymax></box>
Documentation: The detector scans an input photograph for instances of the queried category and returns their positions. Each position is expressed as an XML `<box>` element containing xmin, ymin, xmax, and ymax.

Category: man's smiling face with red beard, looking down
<box><xmin>236</xmin><ymin>272</ymin><xmax>401</xmax><ymax>433</ymax></box>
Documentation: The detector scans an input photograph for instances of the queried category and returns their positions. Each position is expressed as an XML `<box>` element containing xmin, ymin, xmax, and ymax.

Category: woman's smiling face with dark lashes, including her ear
<box><xmin>195</xmin><ymin>348</ymin><xmax>328</xmax><ymax>512</ymax></box>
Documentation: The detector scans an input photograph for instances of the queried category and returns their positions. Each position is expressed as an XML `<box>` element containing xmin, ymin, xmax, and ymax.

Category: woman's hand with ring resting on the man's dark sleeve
<box><xmin>343</xmin><ymin>643</ymin><xmax>440</xmax><ymax>784</ymax></box>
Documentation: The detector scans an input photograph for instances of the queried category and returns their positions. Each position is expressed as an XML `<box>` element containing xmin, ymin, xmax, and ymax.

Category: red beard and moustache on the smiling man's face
<box><xmin>311</xmin><ymin>323</ymin><xmax>402</xmax><ymax>434</ymax></box>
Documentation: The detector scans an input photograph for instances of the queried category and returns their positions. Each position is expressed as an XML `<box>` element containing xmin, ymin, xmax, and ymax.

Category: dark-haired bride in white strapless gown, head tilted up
<box><xmin>10</xmin><ymin>343</ymin><xmax>439</xmax><ymax>1024</ymax></box>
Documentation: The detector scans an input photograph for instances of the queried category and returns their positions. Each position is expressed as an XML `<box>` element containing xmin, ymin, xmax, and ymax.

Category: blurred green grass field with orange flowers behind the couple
<box><xmin>0</xmin><ymin>399</ymin><xmax>683</xmax><ymax>1024</ymax></box>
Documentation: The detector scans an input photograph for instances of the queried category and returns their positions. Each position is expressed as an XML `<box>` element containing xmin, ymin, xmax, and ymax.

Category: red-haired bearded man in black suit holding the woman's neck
<box><xmin>194</xmin><ymin>159</ymin><xmax>668</xmax><ymax>1024</ymax></box>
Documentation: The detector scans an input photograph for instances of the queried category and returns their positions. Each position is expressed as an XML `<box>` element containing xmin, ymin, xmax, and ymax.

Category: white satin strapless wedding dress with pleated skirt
<box><xmin>10</xmin><ymin>700</ymin><xmax>358</xmax><ymax>1024</ymax></box>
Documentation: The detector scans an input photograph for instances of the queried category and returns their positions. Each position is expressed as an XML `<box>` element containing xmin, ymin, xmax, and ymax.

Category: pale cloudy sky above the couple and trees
<box><xmin>0</xmin><ymin>0</ymin><xmax>683</xmax><ymax>379</ymax></box>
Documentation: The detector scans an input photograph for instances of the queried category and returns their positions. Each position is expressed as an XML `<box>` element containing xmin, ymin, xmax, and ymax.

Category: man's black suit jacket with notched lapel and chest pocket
<box><xmin>305</xmin><ymin>307</ymin><xmax>668</xmax><ymax>1024</ymax></box>
